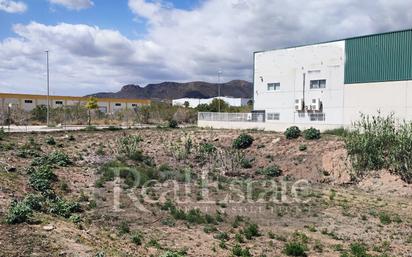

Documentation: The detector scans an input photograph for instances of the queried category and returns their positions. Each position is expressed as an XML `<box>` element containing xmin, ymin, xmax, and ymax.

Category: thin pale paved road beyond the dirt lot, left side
<box><xmin>0</xmin><ymin>125</ymin><xmax>156</xmax><ymax>133</ymax></box>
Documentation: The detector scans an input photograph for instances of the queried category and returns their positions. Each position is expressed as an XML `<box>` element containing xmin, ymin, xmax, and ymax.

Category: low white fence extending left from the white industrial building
<box><xmin>198</xmin><ymin>112</ymin><xmax>265</xmax><ymax>122</ymax></box>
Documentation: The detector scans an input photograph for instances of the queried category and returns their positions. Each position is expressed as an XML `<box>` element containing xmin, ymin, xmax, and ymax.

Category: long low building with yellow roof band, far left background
<box><xmin>0</xmin><ymin>93</ymin><xmax>150</xmax><ymax>113</ymax></box>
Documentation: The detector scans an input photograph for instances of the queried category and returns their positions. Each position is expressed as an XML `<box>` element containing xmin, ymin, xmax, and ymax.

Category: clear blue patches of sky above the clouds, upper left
<box><xmin>0</xmin><ymin>0</ymin><xmax>199</xmax><ymax>39</ymax></box>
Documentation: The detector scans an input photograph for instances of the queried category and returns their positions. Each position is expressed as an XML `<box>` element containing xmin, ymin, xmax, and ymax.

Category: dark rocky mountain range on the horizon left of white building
<box><xmin>88</xmin><ymin>80</ymin><xmax>253</xmax><ymax>100</ymax></box>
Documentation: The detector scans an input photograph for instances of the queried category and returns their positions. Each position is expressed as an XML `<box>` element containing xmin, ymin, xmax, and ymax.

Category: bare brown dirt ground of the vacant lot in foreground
<box><xmin>0</xmin><ymin>128</ymin><xmax>412</xmax><ymax>257</ymax></box>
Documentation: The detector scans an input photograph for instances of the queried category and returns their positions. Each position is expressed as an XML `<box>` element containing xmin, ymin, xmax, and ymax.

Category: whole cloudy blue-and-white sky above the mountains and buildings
<box><xmin>0</xmin><ymin>0</ymin><xmax>412</xmax><ymax>96</ymax></box>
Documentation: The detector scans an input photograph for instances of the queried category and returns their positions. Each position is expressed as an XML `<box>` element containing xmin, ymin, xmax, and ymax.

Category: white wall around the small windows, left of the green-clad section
<box><xmin>254</xmin><ymin>41</ymin><xmax>345</xmax><ymax>125</ymax></box>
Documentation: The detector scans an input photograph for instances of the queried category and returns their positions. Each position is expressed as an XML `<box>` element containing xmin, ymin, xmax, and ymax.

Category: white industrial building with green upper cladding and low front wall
<box><xmin>199</xmin><ymin>30</ymin><xmax>412</xmax><ymax>131</ymax></box>
